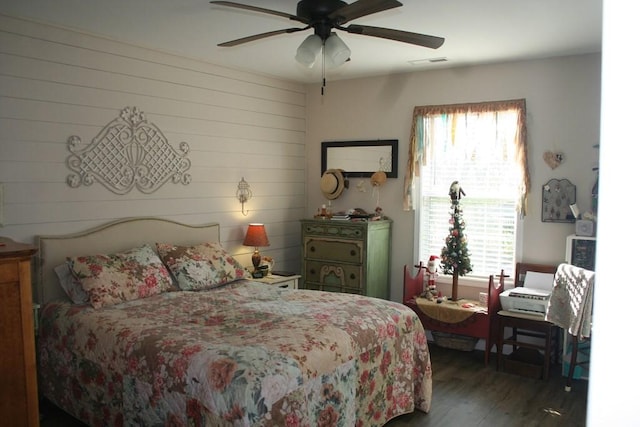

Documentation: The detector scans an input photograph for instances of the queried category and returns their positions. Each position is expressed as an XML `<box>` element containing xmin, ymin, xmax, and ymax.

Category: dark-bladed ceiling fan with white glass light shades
<box><xmin>210</xmin><ymin>0</ymin><xmax>444</xmax><ymax>67</ymax></box>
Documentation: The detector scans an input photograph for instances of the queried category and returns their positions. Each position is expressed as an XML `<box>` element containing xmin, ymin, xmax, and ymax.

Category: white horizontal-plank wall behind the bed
<box><xmin>0</xmin><ymin>15</ymin><xmax>306</xmax><ymax>271</ymax></box>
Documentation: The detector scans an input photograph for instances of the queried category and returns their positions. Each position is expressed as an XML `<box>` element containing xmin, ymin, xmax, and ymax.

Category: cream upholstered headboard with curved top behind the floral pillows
<box><xmin>34</xmin><ymin>217</ymin><xmax>220</xmax><ymax>304</ymax></box>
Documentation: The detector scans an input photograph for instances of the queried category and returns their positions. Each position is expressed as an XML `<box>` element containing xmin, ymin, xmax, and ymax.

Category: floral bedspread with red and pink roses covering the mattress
<box><xmin>39</xmin><ymin>280</ymin><xmax>432</xmax><ymax>427</ymax></box>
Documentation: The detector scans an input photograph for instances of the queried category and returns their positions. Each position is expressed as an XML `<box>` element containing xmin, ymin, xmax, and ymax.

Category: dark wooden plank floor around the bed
<box><xmin>41</xmin><ymin>344</ymin><xmax>587</xmax><ymax>427</ymax></box>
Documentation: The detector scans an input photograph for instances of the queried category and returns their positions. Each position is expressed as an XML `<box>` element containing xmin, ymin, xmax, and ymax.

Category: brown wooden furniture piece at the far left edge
<box><xmin>0</xmin><ymin>237</ymin><xmax>40</xmax><ymax>426</ymax></box>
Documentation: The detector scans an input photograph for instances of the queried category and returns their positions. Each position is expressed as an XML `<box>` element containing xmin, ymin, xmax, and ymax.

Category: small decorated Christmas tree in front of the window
<box><xmin>440</xmin><ymin>181</ymin><xmax>471</xmax><ymax>301</ymax></box>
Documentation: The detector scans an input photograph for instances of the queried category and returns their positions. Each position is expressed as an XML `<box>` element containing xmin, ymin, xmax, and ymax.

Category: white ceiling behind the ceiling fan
<box><xmin>0</xmin><ymin>0</ymin><xmax>602</xmax><ymax>83</ymax></box>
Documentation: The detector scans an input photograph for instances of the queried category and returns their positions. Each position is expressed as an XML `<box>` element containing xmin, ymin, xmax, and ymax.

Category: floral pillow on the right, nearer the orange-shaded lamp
<box><xmin>156</xmin><ymin>243</ymin><xmax>251</xmax><ymax>291</ymax></box>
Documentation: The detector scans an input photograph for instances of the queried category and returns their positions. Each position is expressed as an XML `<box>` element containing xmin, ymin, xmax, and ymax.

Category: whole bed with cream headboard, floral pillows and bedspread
<box><xmin>36</xmin><ymin>218</ymin><xmax>432</xmax><ymax>426</ymax></box>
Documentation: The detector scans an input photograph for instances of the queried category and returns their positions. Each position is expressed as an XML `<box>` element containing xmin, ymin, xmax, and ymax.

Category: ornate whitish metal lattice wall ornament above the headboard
<box><xmin>67</xmin><ymin>107</ymin><xmax>191</xmax><ymax>194</ymax></box>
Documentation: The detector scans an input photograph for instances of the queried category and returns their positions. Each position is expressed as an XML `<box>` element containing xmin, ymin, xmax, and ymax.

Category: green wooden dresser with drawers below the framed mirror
<box><xmin>300</xmin><ymin>219</ymin><xmax>391</xmax><ymax>299</ymax></box>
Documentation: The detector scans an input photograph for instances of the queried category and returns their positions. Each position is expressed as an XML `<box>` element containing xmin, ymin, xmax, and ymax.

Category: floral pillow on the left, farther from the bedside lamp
<box><xmin>68</xmin><ymin>245</ymin><xmax>173</xmax><ymax>308</ymax></box>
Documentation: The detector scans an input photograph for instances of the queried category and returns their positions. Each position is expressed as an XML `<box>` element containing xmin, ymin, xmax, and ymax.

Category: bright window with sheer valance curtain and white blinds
<box><xmin>407</xmin><ymin>100</ymin><xmax>529</xmax><ymax>279</ymax></box>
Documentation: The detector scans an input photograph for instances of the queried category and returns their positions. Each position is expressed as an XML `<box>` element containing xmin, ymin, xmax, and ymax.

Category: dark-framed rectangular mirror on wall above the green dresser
<box><xmin>320</xmin><ymin>139</ymin><xmax>398</xmax><ymax>178</ymax></box>
